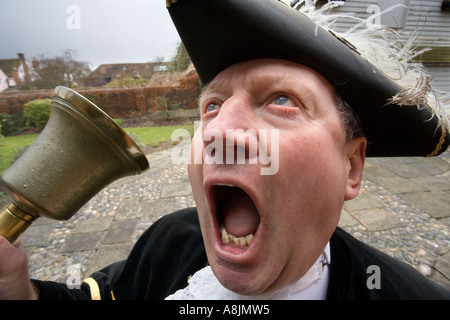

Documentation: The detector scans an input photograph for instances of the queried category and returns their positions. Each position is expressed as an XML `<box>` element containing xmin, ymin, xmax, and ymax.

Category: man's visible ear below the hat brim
<box><xmin>344</xmin><ymin>137</ymin><xmax>367</xmax><ymax>201</ymax></box>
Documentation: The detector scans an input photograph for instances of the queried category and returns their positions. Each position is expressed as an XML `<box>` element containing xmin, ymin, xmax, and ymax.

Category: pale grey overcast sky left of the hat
<box><xmin>0</xmin><ymin>0</ymin><xmax>180</xmax><ymax>67</ymax></box>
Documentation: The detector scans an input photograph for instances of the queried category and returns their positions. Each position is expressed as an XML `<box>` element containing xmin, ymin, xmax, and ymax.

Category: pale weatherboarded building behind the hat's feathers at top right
<box><xmin>326</xmin><ymin>0</ymin><xmax>450</xmax><ymax>93</ymax></box>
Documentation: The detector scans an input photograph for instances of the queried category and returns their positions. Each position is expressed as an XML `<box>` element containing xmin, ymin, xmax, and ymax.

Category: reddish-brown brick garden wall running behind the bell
<box><xmin>0</xmin><ymin>67</ymin><xmax>200</xmax><ymax>119</ymax></box>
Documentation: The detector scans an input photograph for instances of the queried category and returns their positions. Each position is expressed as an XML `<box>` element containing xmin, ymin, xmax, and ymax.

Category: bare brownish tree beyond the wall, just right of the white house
<box><xmin>33</xmin><ymin>49</ymin><xmax>91</xmax><ymax>89</ymax></box>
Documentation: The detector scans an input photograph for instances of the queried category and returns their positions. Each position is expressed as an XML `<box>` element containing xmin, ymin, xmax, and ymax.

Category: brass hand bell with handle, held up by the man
<box><xmin>0</xmin><ymin>87</ymin><xmax>149</xmax><ymax>242</ymax></box>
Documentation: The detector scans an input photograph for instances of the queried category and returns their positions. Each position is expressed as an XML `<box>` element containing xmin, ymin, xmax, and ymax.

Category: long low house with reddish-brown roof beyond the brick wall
<box><xmin>86</xmin><ymin>62</ymin><xmax>167</xmax><ymax>87</ymax></box>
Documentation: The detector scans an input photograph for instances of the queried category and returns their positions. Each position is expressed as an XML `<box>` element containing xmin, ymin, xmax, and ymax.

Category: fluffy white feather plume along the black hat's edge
<box><xmin>283</xmin><ymin>0</ymin><xmax>450</xmax><ymax>127</ymax></box>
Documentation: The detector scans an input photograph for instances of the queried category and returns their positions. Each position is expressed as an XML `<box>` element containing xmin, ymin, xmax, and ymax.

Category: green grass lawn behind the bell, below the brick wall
<box><xmin>0</xmin><ymin>125</ymin><xmax>194</xmax><ymax>173</ymax></box>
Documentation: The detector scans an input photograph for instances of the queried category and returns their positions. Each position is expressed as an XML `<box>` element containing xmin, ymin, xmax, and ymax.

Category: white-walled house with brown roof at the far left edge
<box><xmin>0</xmin><ymin>53</ymin><xmax>33</xmax><ymax>92</ymax></box>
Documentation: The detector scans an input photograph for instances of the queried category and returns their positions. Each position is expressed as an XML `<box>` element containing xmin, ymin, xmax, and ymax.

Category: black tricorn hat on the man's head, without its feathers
<box><xmin>166</xmin><ymin>0</ymin><xmax>450</xmax><ymax>156</ymax></box>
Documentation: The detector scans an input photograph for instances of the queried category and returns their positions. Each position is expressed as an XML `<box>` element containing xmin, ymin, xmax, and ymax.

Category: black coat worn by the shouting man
<box><xmin>33</xmin><ymin>208</ymin><xmax>450</xmax><ymax>300</ymax></box>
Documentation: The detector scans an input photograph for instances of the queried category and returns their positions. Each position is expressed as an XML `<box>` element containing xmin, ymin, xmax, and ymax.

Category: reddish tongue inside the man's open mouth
<box><xmin>222</xmin><ymin>188</ymin><xmax>259</xmax><ymax>237</ymax></box>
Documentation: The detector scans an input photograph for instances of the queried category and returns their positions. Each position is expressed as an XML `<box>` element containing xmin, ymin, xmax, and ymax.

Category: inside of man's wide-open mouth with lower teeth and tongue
<box><xmin>212</xmin><ymin>185</ymin><xmax>260</xmax><ymax>248</ymax></box>
